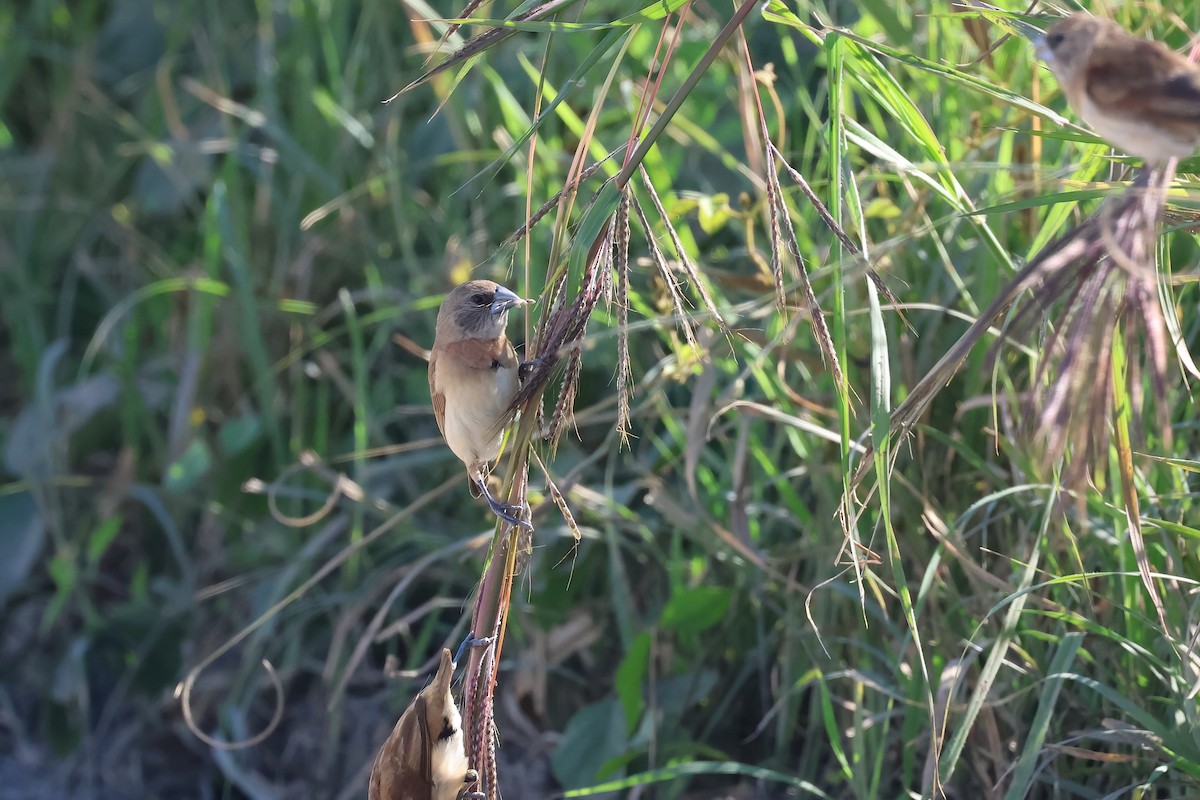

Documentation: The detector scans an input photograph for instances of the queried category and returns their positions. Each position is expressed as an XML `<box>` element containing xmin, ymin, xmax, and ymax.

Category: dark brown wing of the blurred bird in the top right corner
<box><xmin>1084</xmin><ymin>38</ymin><xmax>1200</xmax><ymax>120</ymax></box>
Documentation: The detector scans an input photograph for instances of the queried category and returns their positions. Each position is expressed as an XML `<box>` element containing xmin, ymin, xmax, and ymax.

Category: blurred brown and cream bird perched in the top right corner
<box><xmin>1036</xmin><ymin>11</ymin><xmax>1200</xmax><ymax>166</ymax></box>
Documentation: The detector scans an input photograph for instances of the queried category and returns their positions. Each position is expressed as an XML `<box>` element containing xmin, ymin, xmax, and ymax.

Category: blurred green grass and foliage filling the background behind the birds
<box><xmin>0</xmin><ymin>0</ymin><xmax>1200</xmax><ymax>799</ymax></box>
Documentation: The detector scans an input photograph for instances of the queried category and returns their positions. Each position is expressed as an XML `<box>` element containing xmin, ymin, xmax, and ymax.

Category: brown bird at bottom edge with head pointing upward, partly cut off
<box><xmin>367</xmin><ymin>648</ymin><xmax>484</xmax><ymax>800</ymax></box>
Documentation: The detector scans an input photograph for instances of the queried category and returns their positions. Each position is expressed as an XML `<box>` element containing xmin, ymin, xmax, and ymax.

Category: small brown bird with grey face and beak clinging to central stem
<box><xmin>430</xmin><ymin>281</ymin><xmax>532</xmax><ymax>528</ymax></box>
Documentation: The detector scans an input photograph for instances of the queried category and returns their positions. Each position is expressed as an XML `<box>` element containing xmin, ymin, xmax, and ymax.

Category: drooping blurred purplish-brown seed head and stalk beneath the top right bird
<box><xmin>856</xmin><ymin>160</ymin><xmax>1174</xmax><ymax>483</ymax></box>
